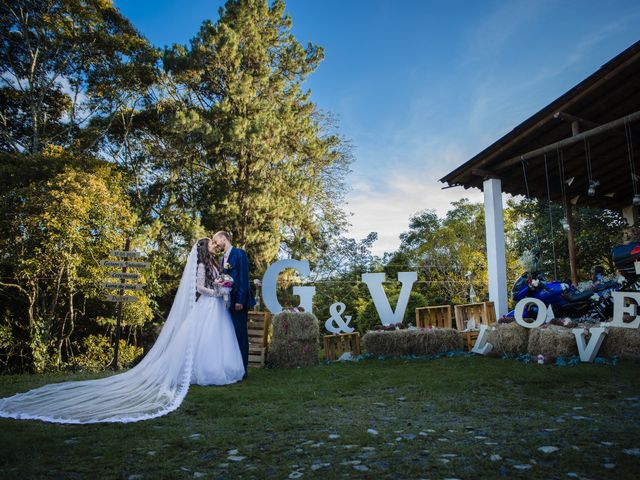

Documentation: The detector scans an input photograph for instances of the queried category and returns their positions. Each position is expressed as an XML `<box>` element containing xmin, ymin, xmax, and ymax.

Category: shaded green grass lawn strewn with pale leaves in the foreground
<box><xmin>0</xmin><ymin>356</ymin><xmax>640</xmax><ymax>480</ymax></box>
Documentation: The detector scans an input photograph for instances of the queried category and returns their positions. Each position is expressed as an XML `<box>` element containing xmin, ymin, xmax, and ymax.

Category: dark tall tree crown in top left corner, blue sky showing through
<box><xmin>0</xmin><ymin>0</ymin><xmax>158</xmax><ymax>154</ymax></box>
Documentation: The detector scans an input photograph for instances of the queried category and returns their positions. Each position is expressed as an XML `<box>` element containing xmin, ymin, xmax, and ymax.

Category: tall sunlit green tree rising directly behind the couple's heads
<box><xmin>165</xmin><ymin>0</ymin><xmax>349</xmax><ymax>264</ymax></box>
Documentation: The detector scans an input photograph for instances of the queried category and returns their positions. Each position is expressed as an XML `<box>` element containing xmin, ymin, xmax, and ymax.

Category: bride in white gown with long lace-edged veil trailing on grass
<box><xmin>0</xmin><ymin>238</ymin><xmax>244</xmax><ymax>423</ymax></box>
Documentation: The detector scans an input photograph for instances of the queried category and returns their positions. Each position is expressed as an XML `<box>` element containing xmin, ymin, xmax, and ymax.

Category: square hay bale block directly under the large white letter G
<box><xmin>267</xmin><ymin>312</ymin><xmax>320</xmax><ymax>368</ymax></box>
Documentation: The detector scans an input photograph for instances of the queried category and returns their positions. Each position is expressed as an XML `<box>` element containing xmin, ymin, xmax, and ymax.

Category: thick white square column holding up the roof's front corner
<box><xmin>483</xmin><ymin>178</ymin><xmax>508</xmax><ymax>318</ymax></box>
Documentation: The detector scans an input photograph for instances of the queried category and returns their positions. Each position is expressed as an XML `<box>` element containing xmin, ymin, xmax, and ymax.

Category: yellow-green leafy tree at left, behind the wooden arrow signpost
<box><xmin>0</xmin><ymin>149</ymin><xmax>142</xmax><ymax>371</ymax></box>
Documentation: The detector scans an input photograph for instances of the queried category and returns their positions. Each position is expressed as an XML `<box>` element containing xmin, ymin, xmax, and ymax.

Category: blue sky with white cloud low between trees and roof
<box><xmin>114</xmin><ymin>0</ymin><xmax>640</xmax><ymax>254</ymax></box>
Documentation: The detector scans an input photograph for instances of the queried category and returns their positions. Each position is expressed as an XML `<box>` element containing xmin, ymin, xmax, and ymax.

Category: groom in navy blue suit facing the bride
<box><xmin>212</xmin><ymin>232</ymin><xmax>256</xmax><ymax>378</ymax></box>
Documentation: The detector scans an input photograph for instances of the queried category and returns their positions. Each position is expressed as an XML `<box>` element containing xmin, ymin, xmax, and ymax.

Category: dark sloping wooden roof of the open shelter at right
<box><xmin>440</xmin><ymin>41</ymin><xmax>640</xmax><ymax>209</ymax></box>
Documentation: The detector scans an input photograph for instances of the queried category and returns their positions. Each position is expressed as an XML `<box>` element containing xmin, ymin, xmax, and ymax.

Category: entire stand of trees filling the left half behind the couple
<box><xmin>0</xmin><ymin>0</ymin><xmax>351</xmax><ymax>371</ymax></box>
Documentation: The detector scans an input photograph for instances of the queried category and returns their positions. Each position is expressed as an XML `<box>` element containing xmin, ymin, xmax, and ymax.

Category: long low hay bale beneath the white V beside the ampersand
<box><xmin>362</xmin><ymin>328</ymin><xmax>462</xmax><ymax>357</ymax></box>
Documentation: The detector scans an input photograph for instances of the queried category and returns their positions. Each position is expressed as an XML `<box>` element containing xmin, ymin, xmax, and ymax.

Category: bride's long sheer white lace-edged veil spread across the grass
<box><xmin>0</xmin><ymin>244</ymin><xmax>197</xmax><ymax>423</ymax></box>
